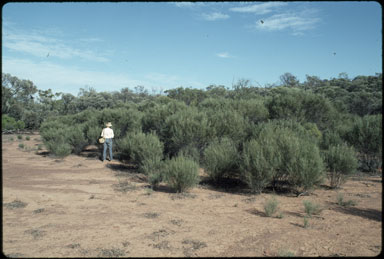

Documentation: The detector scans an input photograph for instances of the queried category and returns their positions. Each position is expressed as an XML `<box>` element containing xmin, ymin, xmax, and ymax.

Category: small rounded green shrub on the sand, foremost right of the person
<box><xmin>164</xmin><ymin>156</ymin><xmax>199</xmax><ymax>192</ymax></box>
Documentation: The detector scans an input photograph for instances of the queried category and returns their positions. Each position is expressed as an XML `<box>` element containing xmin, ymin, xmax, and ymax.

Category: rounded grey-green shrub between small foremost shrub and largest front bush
<box><xmin>204</xmin><ymin>138</ymin><xmax>239</xmax><ymax>182</ymax></box>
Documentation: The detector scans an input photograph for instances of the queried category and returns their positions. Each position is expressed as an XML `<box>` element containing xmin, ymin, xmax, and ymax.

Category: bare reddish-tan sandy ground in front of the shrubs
<box><xmin>2</xmin><ymin>133</ymin><xmax>382</xmax><ymax>258</ymax></box>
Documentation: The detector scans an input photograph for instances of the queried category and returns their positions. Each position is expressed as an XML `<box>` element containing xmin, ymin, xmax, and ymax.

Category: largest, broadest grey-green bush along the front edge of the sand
<box><xmin>241</xmin><ymin>122</ymin><xmax>324</xmax><ymax>192</ymax></box>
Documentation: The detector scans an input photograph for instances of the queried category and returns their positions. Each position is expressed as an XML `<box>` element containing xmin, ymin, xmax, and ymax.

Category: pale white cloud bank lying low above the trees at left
<box><xmin>2</xmin><ymin>57</ymin><xmax>204</xmax><ymax>95</ymax></box>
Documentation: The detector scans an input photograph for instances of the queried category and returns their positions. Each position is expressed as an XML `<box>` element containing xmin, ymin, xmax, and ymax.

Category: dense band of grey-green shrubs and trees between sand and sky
<box><xmin>2</xmin><ymin>73</ymin><xmax>382</xmax><ymax>193</ymax></box>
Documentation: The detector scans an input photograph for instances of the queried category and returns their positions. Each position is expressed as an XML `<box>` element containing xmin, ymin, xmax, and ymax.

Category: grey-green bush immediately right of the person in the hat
<box><xmin>119</xmin><ymin>132</ymin><xmax>164</xmax><ymax>174</ymax></box>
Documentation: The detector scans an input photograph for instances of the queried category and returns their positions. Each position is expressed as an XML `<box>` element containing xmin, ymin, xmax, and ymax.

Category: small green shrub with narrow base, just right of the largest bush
<box><xmin>325</xmin><ymin>144</ymin><xmax>357</xmax><ymax>188</ymax></box>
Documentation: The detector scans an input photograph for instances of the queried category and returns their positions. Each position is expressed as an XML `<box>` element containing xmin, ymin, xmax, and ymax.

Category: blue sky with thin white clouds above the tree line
<box><xmin>2</xmin><ymin>1</ymin><xmax>382</xmax><ymax>95</ymax></box>
